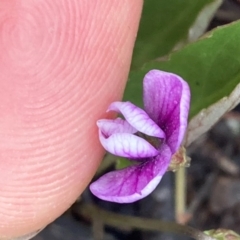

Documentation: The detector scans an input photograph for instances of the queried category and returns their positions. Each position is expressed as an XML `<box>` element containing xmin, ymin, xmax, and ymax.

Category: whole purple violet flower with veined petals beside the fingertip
<box><xmin>90</xmin><ymin>70</ymin><xmax>190</xmax><ymax>203</ymax></box>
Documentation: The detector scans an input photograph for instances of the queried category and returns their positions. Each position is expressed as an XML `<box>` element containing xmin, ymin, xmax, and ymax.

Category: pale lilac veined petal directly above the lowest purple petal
<box><xmin>99</xmin><ymin>129</ymin><xmax>158</xmax><ymax>160</ymax></box>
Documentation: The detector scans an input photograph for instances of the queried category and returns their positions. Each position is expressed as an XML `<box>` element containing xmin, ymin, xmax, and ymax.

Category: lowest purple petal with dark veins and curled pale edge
<box><xmin>90</xmin><ymin>144</ymin><xmax>171</xmax><ymax>203</ymax></box>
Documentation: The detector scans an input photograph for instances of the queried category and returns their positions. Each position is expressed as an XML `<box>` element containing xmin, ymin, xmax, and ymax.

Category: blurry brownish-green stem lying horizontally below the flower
<box><xmin>77</xmin><ymin>204</ymin><xmax>214</xmax><ymax>240</ymax></box>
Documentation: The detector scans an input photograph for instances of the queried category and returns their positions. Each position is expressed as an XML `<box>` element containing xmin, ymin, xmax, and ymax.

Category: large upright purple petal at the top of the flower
<box><xmin>143</xmin><ymin>70</ymin><xmax>190</xmax><ymax>153</ymax></box>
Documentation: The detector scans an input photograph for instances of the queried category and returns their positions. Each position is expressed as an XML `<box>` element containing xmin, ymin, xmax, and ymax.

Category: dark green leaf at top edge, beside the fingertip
<box><xmin>132</xmin><ymin>0</ymin><xmax>214</xmax><ymax>69</ymax></box>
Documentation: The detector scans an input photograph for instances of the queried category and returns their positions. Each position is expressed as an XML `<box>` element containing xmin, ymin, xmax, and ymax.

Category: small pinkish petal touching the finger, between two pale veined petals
<box><xmin>97</xmin><ymin>118</ymin><xmax>137</xmax><ymax>137</ymax></box>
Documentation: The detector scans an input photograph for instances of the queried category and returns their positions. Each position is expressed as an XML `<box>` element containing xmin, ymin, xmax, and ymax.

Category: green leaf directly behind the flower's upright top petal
<box><xmin>124</xmin><ymin>22</ymin><xmax>240</xmax><ymax>117</ymax></box>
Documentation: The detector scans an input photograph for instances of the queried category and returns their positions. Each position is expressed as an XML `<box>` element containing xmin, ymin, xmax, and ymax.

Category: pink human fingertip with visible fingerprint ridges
<box><xmin>0</xmin><ymin>0</ymin><xmax>142</xmax><ymax>236</ymax></box>
